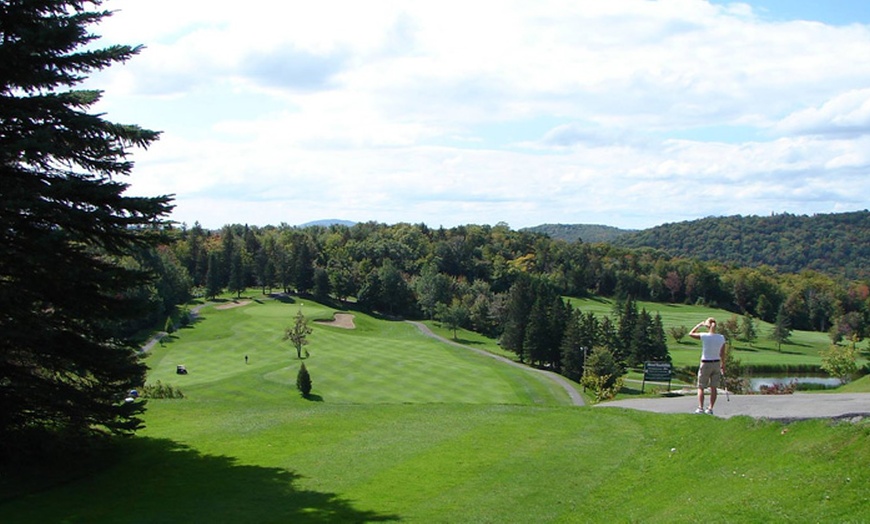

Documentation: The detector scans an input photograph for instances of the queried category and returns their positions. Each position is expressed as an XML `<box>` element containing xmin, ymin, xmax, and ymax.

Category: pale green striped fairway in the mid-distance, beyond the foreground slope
<box><xmin>149</xmin><ymin>300</ymin><xmax>570</xmax><ymax>405</ymax></box>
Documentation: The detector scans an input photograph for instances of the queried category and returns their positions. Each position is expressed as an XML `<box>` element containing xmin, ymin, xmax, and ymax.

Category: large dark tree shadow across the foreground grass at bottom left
<box><xmin>0</xmin><ymin>438</ymin><xmax>400</xmax><ymax>523</ymax></box>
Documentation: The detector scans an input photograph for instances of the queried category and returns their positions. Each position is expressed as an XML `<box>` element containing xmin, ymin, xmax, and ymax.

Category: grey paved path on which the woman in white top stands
<box><xmin>597</xmin><ymin>390</ymin><xmax>870</xmax><ymax>421</ymax></box>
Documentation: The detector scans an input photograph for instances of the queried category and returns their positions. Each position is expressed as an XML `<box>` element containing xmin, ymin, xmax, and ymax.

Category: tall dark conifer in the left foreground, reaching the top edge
<box><xmin>0</xmin><ymin>0</ymin><xmax>171</xmax><ymax>452</ymax></box>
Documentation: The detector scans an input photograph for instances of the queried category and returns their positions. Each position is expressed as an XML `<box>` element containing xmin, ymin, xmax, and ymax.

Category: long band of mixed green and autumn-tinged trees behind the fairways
<box><xmin>154</xmin><ymin>218</ymin><xmax>870</xmax><ymax>352</ymax></box>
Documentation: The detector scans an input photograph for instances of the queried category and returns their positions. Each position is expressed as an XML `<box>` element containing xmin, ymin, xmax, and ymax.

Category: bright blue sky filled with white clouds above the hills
<box><xmin>85</xmin><ymin>0</ymin><xmax>870</xmax><ymax>229</ymax></box>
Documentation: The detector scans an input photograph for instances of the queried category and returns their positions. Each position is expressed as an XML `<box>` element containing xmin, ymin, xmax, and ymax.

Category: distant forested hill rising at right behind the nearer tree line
<box><xmin>610</xmin><ymin>210</ymin><xmax>870</xmax><ymax>278</ymax></box>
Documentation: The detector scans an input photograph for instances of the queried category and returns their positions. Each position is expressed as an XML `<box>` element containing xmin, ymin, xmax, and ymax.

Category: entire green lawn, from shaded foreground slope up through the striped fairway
<box><xmin>0</xmin><ymin>292</ymin><xmax>870</xmax><ymax>523</ymax></box>
